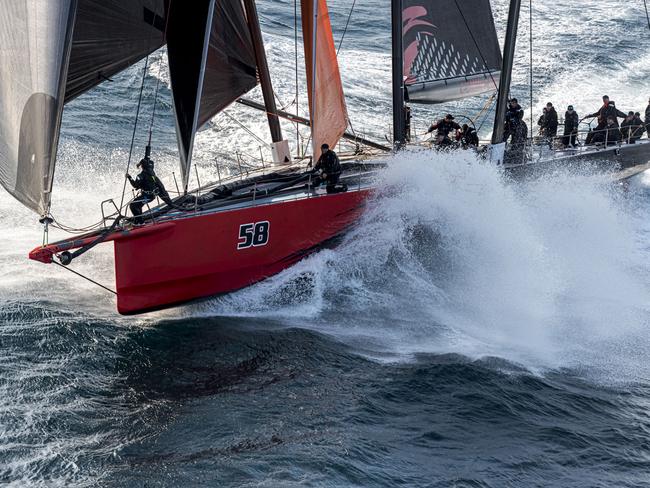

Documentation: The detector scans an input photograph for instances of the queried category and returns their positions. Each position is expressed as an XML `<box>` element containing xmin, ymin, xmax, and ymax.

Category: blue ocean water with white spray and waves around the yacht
<box><xmin>0</xmin><ymin>0</ymin><xmax>650</xmax><ymax>487</ymax></box>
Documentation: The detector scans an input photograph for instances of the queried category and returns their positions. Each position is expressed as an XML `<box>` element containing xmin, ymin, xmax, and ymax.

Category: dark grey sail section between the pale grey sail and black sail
<box><xmin>65</xmin><ymin>0</ymin><xmax>170</xmax><ymax>102</ymax></box>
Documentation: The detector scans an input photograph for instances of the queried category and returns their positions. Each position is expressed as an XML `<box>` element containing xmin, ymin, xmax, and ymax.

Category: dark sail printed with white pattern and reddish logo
<box><xmin>402</xmin><ymin>0</ymin><xmax>501</xmax><ymax>103</ymax></box>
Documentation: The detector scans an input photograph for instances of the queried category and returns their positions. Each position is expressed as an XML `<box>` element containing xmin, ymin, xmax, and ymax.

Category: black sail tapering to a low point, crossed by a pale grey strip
<box><xmin>167</xmin><ymin>0</ymin><xmax>257</xmax><ymax>189</ymax></box>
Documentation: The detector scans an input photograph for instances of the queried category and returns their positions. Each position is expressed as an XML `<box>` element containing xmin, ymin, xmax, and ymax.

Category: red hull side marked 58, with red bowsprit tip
<box><xmin>30</xmin><ymin>188</ymin><xmax>371</xmax><ymax>315</ymax></box>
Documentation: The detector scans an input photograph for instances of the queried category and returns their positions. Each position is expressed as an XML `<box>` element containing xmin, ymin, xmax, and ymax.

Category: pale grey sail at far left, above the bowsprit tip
<box><xmin>0</xmin><ymin>0</ymin><xmax>76</xmax><ymax>215</ymax></box>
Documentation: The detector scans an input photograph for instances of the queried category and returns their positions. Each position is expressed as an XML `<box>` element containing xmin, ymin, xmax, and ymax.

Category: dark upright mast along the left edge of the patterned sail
<box><xmin>391</xmin><ymin>0</ymin><xmax>406</xmax><ymax>149</ymax></box>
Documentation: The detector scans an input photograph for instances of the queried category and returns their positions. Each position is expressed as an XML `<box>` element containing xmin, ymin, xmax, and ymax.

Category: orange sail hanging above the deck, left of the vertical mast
<box><xmin>301</xmin><ymin>0</ymin><xmax>348</xmax><ymax>159</ymax></box>
